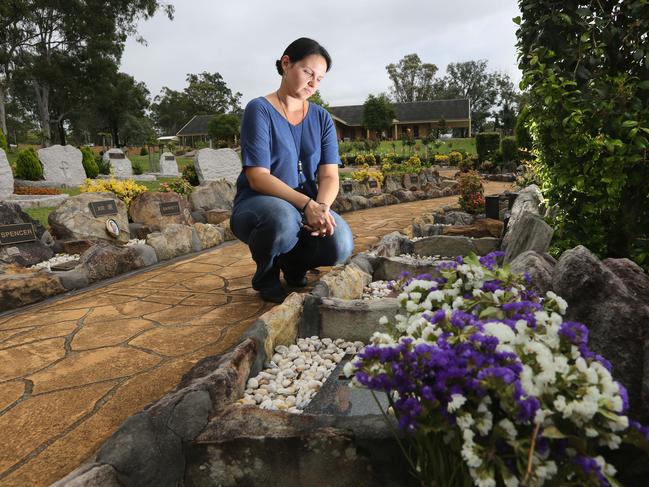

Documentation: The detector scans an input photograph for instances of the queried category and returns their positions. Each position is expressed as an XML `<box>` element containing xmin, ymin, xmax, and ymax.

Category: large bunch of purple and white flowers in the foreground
<box><xmin>345</xmin><ymin>252</ymin><xmax>647</xmax><ymax>487</ymax></box>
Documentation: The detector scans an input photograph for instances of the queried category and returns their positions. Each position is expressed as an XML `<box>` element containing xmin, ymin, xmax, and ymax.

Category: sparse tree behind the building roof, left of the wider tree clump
<box><xmin>385</xmin><ymin>54</ymin><xmax>437</xmax><ymax>102</ymax></box>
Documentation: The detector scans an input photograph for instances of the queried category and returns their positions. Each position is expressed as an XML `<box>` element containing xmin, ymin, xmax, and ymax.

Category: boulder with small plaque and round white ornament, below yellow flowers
<box><xmin>48</xmin><ymin>193</ymin><xmax>130</xmax><ymax>243</ymax></box>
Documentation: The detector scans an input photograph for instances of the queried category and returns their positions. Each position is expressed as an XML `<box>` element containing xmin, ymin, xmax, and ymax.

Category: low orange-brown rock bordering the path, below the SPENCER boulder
<box><xmin>0</xmin><ymin>271</ymin><xmax>65</xmax><ymax>311</ymax></box>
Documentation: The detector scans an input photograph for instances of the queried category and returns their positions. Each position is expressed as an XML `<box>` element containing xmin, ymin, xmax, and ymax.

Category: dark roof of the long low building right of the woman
<box><xmin>329</xmin><ymin>98</ymin><xmax>470</xmax><ymax>126</ymax></box>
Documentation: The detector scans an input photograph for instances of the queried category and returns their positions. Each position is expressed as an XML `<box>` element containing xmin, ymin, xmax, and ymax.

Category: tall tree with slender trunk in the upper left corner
<box><xmin>0</xmin><ymin>0</ymin><xmax>173</xmax><ymax>145</ymax></box>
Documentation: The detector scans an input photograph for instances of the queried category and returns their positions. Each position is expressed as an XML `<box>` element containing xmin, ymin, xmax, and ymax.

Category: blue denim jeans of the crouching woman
<box><xmin>230</xmin><ymin>195</ymin><xmax>354</xmax><ymax>290</ymax></box>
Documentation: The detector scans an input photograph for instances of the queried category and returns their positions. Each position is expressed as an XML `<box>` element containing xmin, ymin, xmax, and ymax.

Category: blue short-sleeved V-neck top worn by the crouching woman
<box><xmin>234</xmin><ymin>96</ymin><xmax>340</xmax><ymax>205</ymax></box>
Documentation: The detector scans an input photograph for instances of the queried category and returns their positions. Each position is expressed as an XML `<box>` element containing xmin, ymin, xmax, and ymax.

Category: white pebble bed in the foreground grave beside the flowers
<box><xmin>239</xmin><ymin>336</ymin><xmax>365</xmax><ymax>414</ymax></box>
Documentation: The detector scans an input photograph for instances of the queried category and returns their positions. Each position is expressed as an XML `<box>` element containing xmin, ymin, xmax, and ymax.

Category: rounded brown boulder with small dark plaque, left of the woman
<box><xmin>129</xmin><ymin>191</ymin><xmax>194</xmax><ymax>231</ymax></box>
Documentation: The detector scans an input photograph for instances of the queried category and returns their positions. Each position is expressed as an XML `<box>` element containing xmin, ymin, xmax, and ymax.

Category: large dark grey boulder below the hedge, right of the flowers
<box><xmin>552</xmin><ymin>245</ymin><xmax>649</xmax><ymax>421</ymax></box>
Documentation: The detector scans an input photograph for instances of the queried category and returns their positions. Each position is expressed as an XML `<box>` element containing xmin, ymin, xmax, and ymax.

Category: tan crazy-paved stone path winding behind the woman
<box><xmin>0</xmin><ymin>183</ymin><xmax>509</xmax><ymax>487</ymax></box>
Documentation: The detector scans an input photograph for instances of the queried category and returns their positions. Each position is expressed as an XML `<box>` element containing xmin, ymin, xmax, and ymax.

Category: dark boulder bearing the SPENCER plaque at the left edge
<box><xmin>0</xmin><ymin>201</ymin><xmax>54</xmax><ymax>267</ymax></box>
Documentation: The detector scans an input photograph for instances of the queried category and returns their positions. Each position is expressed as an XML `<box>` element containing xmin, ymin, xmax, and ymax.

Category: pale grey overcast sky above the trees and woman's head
<box><xmin>121</xmin><ymin>0</ymin><xmax>520</xmax><ymax>106</ymax></box>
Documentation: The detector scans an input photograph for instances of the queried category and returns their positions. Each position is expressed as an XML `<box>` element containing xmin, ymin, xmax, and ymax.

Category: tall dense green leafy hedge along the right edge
<box><xmin>516</xmin><ymin>0</ymin><xmax>649</xmax><ymax>269</ymax></box>
